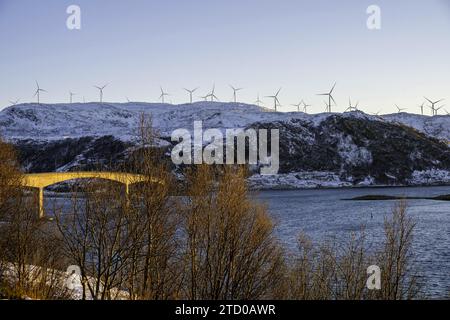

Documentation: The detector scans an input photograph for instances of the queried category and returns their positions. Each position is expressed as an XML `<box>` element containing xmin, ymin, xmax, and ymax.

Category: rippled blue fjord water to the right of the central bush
<box><xmin>255</xmin><ymin>187</ymin><xmax>450</xmax><ymax>298</ymax></box>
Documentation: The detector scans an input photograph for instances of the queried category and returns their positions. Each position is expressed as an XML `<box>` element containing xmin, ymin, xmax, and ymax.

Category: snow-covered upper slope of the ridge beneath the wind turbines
<box><xmin>0</xmin><ymin>102</ymin><xmax>450</xmax><ymax>140</ymax></box>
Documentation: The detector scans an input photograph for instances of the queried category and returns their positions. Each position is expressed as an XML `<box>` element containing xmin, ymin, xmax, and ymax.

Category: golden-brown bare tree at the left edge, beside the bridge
<box><xmin>0</xmin><ymin>138</ymin><xmax>68</xmax><ymax>299</ymax></box>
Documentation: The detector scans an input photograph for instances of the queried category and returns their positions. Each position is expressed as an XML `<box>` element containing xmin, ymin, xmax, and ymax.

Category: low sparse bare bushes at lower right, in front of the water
<box><xmin>284</xmin><ymin>201</ymin><xmax>419</xmax><ymax>300</ymax></box>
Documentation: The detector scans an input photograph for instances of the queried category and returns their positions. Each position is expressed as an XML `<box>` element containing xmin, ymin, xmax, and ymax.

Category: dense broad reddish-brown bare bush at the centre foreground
<box><xmin>182</xmin><ymin>165</ymin><xmax>283</xmax><ymax>299</ymax></box>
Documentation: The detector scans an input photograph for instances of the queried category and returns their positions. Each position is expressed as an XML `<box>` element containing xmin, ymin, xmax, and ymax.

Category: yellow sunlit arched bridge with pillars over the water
<box><xmin>22</xmin><ymin>172</ymin><xmax>160</xmax><ymax>218</ymax></box>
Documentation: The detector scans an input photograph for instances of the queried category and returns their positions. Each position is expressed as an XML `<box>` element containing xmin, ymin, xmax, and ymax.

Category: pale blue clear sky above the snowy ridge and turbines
<box><xmin>0</xmin><ymin>0</ymin><xmax>450</xmax><ymax>113</ymax></box>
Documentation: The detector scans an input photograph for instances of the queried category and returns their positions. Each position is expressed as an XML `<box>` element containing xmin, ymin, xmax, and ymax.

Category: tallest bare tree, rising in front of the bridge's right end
<box><xmin>126</xmin><ymin>114</ymin><xmax>182</xmax><ymax>299</ymax></box>
